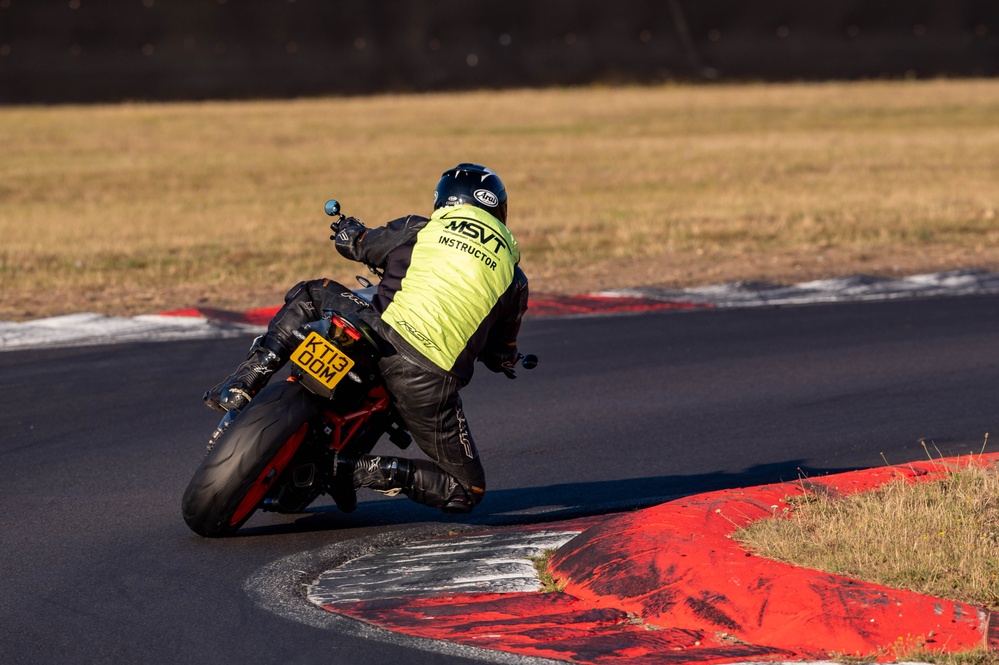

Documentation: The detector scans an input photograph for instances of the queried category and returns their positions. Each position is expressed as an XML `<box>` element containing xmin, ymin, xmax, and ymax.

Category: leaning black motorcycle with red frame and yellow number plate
<box><xmin>182</xmin><ymin>200</ymin><xmax>537</xmax><ymax>537</ymax></box>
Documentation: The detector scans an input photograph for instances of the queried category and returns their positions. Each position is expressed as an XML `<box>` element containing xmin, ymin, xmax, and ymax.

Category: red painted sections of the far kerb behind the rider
<box><xmin>161</xmin><ymin>294</ymin><xmax>709</xmax><ymax>326</ymax></box>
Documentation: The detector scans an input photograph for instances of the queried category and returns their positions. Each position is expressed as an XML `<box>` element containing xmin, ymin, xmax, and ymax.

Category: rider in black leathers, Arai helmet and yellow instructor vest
<box><xmin>204</xmin><ymin>163</ymin><xmax>528</xmax><ymax>513</ymax></box>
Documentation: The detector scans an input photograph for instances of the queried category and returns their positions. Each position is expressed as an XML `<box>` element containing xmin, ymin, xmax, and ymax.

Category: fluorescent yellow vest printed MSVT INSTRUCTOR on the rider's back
<box><xmin>382</xmin><ymin>205</ymin><xmax>520</xmax><ymax>370</ymax></box>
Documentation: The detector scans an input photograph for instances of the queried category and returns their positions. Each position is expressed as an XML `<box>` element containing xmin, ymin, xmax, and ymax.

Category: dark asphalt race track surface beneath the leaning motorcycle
<box><xmin>0</xmin><ymin>296</ymin><xmax>999</xmax><ymax>664</ymax></box>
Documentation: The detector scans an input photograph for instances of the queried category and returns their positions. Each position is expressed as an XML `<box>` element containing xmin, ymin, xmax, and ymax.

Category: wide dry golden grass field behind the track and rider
<box><xmin>0</xmin><ymin>80</ymin><xmax>999</xmax><ymax>320</ymax></box>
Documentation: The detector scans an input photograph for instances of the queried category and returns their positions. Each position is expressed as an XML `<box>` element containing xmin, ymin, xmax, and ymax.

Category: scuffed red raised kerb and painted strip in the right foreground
<box><xmin>327</xmin><ymin>454</ymin><xmax>999</xmax><ymax>665</ymax></box>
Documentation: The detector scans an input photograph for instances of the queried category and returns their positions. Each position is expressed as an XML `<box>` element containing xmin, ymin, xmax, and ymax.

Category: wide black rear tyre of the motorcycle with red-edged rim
<box><xmin>181</xmin><ymin>381</ymin><xmax>319</xmax><ymax>538</ymax></box>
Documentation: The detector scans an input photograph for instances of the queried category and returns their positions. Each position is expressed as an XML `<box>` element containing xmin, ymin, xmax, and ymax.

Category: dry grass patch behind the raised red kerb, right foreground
<box><xmin>734</xmin><ymin>444</ymin><xmax>999</xmax><ymax>665</ymax></box>
